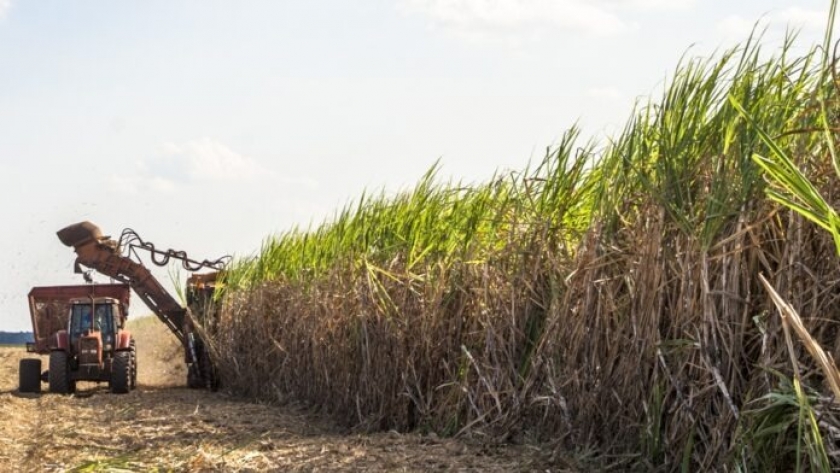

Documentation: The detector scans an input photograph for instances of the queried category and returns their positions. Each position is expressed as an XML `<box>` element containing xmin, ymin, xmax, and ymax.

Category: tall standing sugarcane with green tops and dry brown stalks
<box><xmin>205</xmin><ymin>13</ymin><xmax>840</xmax><ymax>471</ymax></box>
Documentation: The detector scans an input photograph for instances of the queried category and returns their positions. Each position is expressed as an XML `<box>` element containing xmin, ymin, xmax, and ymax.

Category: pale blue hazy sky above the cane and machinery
<box><xmin>0</xmin><ymin>0</ymin><xmax>829</xmax><ymax>330</ymax></box>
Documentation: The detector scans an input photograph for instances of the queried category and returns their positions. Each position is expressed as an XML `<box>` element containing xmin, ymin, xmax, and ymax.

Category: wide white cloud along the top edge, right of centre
<box><xmin>402</xmin><ymin>0</ymin><xmax>630</xmax><ymax>42</ymax></box>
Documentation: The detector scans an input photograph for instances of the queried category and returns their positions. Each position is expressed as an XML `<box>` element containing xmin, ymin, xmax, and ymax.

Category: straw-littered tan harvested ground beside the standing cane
<box><xmin>0</xmin><ymin>319</ymin><xmax>564</xmax><ymax>472</ymax></box>
